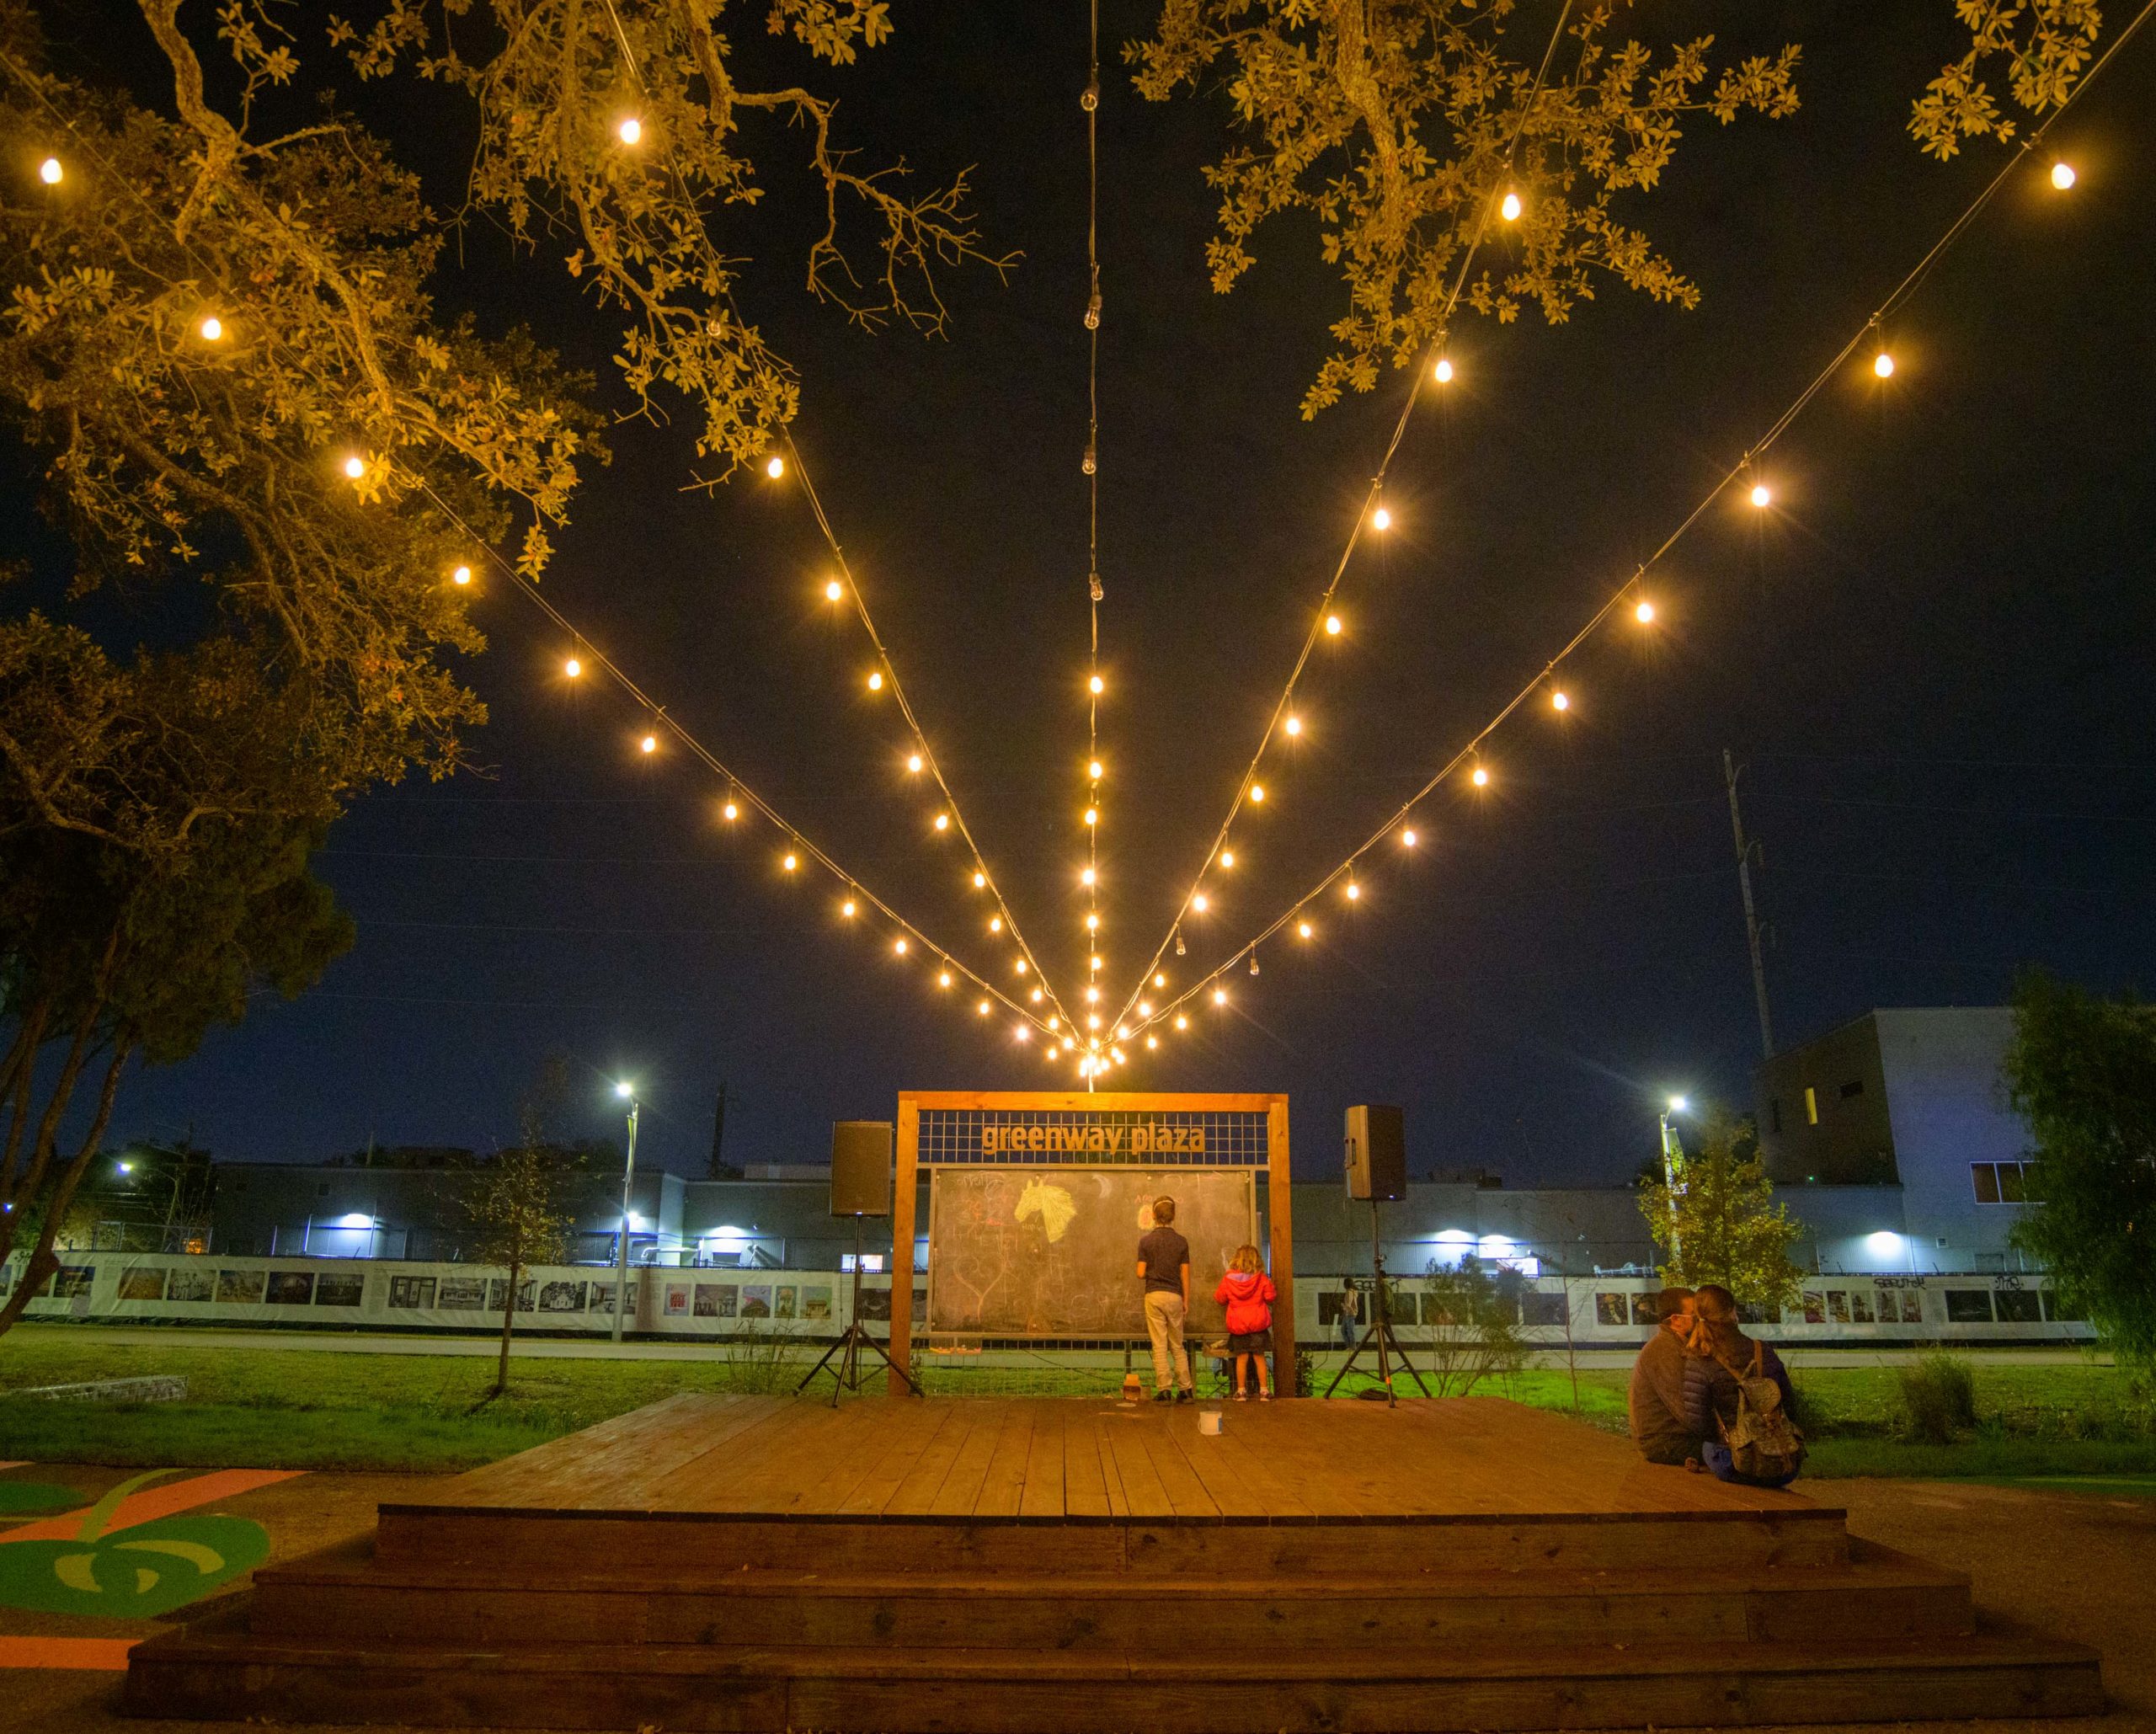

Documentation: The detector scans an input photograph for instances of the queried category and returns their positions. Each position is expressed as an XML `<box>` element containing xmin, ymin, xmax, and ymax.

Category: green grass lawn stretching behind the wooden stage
<box><xmin>0</xmin><ymin>1326</ymin><xmax>2156</xmax><ymax>1486</ymax></box>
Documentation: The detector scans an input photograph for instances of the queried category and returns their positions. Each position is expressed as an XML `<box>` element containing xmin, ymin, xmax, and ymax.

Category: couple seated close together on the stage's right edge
<box><xmin>1628</xmin><ymin>1283</ymin><xmax>1805</xmax><ymax>1488</ymax></box>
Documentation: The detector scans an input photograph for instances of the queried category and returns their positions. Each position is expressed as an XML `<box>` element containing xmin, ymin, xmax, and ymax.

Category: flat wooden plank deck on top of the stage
<box><xmin>397</xmin><ymin>1395</ymin><xmax>1816</xmax><ymax>1523</ymax></box>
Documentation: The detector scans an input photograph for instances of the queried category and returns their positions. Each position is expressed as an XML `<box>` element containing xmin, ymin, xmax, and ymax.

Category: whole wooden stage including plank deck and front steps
<box><xmin>127</xmin><ymin>1395</ymin><xmax>2102</xmax><ymax>1734</ymax></box>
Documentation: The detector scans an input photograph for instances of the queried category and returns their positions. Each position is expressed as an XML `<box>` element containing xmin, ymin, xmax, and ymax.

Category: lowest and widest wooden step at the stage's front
<box><xmin>125</xmin><ymin>1629</ymin><xmax>2105</xmax><ymax>1734</ymax></box>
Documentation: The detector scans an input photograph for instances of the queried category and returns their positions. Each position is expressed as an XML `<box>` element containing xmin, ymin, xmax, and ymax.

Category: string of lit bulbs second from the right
<box><xmin>1089</xmin><ymin>0</ymin><xmax>1572</xmax><ymax>1024</ymax></box>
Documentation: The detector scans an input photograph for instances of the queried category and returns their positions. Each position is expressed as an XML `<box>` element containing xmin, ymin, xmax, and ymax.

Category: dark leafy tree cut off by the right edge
<box><xmin>2001</xmin><ymin>970</ymin><xmax>2156</xmax><ymax>1376</ymax></box>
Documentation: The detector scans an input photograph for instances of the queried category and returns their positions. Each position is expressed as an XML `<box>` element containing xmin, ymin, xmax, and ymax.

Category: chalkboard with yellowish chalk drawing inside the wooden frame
<box><xmin>927</xmin><ymin>1166</ymin><xmax>1257</xmax><ymax>1337</ymax></box>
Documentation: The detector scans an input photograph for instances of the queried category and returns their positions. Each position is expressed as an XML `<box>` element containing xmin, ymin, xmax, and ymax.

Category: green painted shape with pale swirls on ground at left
<box><xmin>0</xmin><ymin>1469</ymin><xmax>270</xmax><ymax>1619</ymax></box>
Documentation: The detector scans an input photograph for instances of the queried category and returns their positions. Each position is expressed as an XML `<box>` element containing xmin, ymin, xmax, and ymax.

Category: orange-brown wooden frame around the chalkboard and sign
<box><xmin>890</xmin><ymin>1089</ymin><xmax>1296</xmax><ymax>1397</ymax></box>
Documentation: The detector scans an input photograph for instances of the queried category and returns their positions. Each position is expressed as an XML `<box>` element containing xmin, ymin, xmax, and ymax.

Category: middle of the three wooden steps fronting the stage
<box><xmin>250</xmin><ymin>1545</ymin><xmax>1972</xmax><ymax>1657</ymax></box>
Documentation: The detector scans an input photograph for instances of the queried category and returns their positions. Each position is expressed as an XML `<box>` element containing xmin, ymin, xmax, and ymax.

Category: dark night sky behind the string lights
<box><xmin>46</xmin><ymin>0</ymin><xmax>2156</xmax><ymax>1184</ymax></box>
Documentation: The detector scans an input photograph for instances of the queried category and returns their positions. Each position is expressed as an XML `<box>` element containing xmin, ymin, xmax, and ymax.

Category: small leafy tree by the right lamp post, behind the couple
<box><xmin>1639</xmin><ymin>1118</ymin><xmax>1805</xmax><ymax>1307</ymax></box>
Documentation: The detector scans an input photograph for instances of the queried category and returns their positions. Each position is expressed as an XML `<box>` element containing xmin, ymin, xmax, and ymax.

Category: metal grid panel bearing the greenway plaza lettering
<box><xmin>921</xmin><ymin>1108</ymin><xmax>1267</xmax><ymax>1169</ymax></box>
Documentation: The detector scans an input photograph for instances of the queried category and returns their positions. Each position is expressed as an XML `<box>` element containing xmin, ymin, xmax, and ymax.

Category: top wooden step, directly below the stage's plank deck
<box><xmin>375</xmin><ymin>1506</ymin><xmax>1849</xmax><ymax>1577</ymax></box>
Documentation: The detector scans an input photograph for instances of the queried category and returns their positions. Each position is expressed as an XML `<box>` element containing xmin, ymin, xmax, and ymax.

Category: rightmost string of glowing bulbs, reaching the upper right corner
<box><xmin>1103</xmin><ymin>0</ymin><xmax>2156</xmax><ymax>1056</ymax></box>
